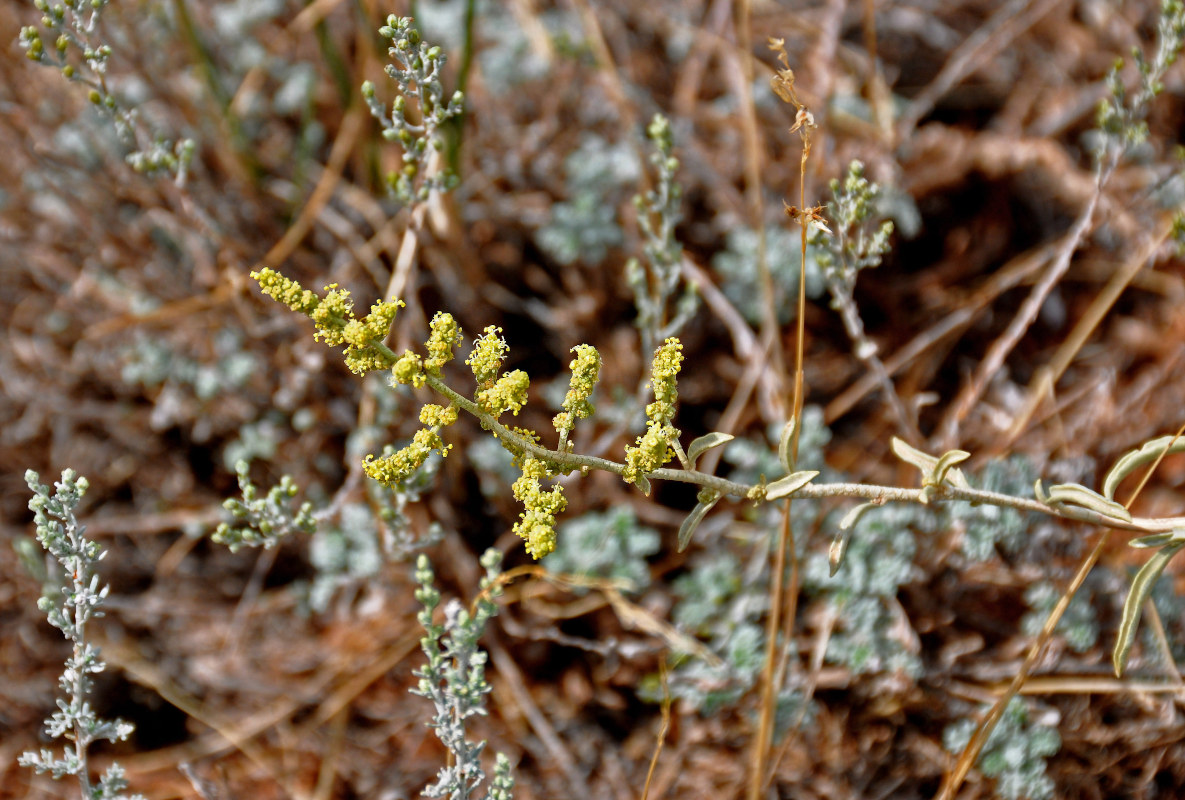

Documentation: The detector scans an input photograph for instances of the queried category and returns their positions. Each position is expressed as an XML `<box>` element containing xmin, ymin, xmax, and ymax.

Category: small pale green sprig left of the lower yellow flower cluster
<box><xmin>213</xmin><ymin>461</ymin><xmax>316</xmax><ymax>552</ymax></box>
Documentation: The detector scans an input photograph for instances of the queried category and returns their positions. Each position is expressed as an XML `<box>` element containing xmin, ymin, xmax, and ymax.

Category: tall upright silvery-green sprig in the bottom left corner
<box><xmin>18</xmin><ymin>469</ymin><xmax>140</xmax><ymax>800</ymax></box>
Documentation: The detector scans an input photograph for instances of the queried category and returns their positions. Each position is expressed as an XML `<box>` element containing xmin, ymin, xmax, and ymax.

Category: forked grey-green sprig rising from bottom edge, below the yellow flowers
<box><xmin>411</xmin><ymin>549</ymin><xmax>514</xmax><ymax>800</ymax></box>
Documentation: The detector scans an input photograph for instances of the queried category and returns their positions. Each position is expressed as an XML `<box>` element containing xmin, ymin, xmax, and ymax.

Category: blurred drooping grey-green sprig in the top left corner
<box><xmin>18</xmin><ymin>0</ymin><xmax>197</xmax><ymax>186</ymax></box>
